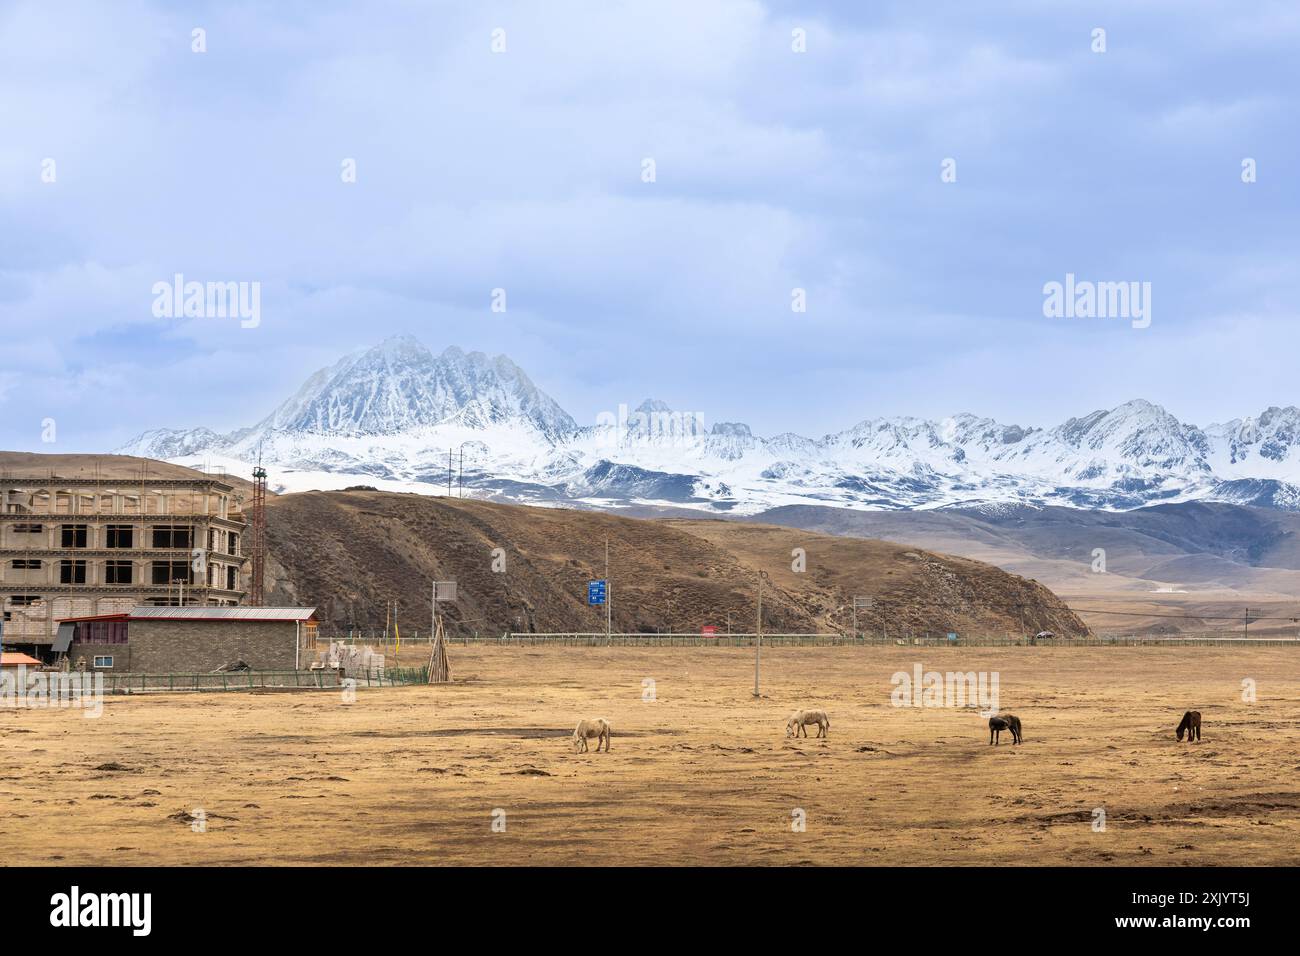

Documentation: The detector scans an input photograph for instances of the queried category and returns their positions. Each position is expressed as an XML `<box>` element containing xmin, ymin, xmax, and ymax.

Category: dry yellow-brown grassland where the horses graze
<box><xmin>0</xmin><ymin>648</ymin><xmax>1300</xmax><ymax>865</ymax></box>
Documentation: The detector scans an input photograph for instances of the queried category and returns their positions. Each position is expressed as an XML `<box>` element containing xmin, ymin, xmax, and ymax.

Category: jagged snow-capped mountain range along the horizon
<box><xmin>118</xmin><ymin>337</ymin><xmax>1300</xmax><ymax>514</ymax></box>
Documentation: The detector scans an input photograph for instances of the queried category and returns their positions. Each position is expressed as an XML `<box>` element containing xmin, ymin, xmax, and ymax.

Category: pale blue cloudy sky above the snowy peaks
<box><xmin>0</xmin><ymin>0</ymin><xmax>1300</xmax><ymax>451</ymax></box>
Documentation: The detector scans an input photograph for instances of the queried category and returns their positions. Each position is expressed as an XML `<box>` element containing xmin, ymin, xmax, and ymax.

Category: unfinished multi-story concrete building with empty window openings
<box><xmin>0</xmin><ymin>477</ymin><xmax>246</xmax><ymax>659</ymax></box>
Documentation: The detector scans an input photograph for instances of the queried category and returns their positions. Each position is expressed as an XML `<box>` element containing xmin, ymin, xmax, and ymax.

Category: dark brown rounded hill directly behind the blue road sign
<box><xmin>267</xmin><ymin>490</ymin><xmax>1087</xmax><ymax>635</ymax></box>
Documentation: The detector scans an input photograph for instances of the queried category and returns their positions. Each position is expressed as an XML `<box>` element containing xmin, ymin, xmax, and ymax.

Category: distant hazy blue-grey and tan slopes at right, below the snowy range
<box><xmin>754</xmin><ymin>501</ymin><xmax>1300</xmax><ymax>637</ymax></box>
